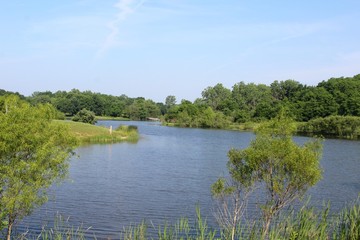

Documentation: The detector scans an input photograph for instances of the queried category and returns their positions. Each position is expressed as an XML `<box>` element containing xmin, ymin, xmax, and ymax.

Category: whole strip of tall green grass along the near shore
<box><xmin>9</xmin><ymin>199</ymin><xmax>360</xmax><ymax>240</ymax></box>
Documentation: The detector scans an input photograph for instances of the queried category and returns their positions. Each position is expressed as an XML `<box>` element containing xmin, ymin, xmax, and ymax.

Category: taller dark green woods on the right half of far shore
<box><xmin>165</xmin><ymin>75</ymin><xmax>360</xmax><ymax>127</ymax></box>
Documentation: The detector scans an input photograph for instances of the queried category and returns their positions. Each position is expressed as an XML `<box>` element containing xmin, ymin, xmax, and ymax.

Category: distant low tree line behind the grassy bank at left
<box><xmin>0</xmin><ymin>89</ymin><xmax>163</xmax><ymax>120</ymax></box>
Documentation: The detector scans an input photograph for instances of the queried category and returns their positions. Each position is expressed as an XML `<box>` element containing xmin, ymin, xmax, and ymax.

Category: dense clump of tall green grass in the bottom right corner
<box><xmin>269</xmin><ymin>199</ymin><xmax>360</xmax><ymax>240</ymax></box>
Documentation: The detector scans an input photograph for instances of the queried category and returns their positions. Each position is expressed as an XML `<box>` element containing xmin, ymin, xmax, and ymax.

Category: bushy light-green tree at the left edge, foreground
<box><xmin>0</xmin><ymin>96</ymin><xmax>76</xmax><ymax>240</ymax></box>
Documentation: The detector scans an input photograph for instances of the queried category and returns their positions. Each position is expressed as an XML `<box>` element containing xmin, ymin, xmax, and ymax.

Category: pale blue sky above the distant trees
<box><xmin>0</xmin><ymin>0</ymin><xmax>360</xmax><ymax>102</ymax></box>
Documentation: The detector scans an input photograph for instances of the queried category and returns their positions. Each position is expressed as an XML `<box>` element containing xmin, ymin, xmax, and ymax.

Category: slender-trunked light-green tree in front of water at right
<box><xmin>212</xmin><ymin>111</ymin><xmax>321</xmax><ymax>238</ymax></box>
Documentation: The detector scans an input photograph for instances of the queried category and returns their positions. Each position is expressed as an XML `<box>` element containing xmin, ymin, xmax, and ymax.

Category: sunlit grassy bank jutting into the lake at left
<box><xmin>58</xmin><ymin>121</ymin><xmax>139</xmax><ymax>144</ymax></box>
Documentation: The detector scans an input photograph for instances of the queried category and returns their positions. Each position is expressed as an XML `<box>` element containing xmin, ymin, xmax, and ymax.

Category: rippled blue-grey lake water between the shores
<box><xmin>18</xmin><ymin>121</ymin><xmax>360</xmax><ymax>239</ymax></box>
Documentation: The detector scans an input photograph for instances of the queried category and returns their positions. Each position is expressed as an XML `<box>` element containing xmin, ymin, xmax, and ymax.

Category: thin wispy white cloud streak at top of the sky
<box><xmin>96</xmin><ymin>0</ymin><xmax>145</xmax><ymax>57</ymax></box>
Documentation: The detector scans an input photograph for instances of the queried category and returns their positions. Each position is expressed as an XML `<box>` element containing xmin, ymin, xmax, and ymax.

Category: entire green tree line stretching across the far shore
<box><xmin>0</xmin><ymin>74</ymin><xmax>360</xmax><ymax>124</ymax></box>
